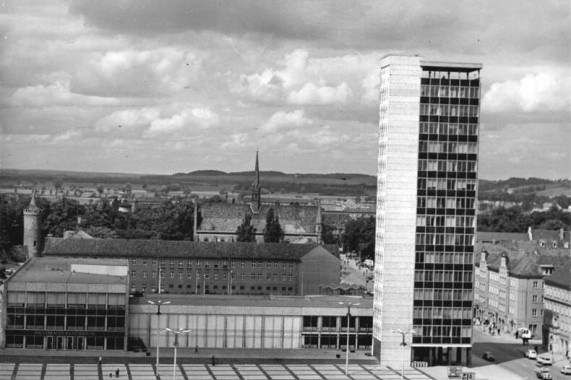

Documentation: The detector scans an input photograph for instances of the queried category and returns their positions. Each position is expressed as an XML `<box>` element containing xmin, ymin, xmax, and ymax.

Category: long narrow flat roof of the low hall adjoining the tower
<box><xmin>134</xmin><ymin>294</ymin><xmax>373</xmax><ymax>311</ymax></box>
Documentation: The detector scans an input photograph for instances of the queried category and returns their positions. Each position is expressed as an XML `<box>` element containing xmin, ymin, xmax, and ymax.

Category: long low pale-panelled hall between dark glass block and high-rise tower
<box><xmin>133</xmin><ymin>295</ymin><xmax>373</xmax><ymax>350</ymax></box>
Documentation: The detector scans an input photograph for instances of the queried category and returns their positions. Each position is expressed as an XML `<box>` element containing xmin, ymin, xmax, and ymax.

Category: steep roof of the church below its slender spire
<box><xmin>197</xmin><ymin>203</ymin><xmax>319</xmax><ymax>235</ymax></box>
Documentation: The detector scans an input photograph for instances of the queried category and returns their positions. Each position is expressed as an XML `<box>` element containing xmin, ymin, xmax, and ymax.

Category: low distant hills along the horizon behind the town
<box><xmin>0</xmin><ymin>169</ymin><xmax>571</xmax><ymax>201</ymax></box>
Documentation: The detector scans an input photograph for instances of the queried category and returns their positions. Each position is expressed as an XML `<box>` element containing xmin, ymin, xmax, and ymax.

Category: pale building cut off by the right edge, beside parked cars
<box><xmin>543</xmin><ymin>259</ymin><xmax>571</xmax><ymax>359</ymax></box>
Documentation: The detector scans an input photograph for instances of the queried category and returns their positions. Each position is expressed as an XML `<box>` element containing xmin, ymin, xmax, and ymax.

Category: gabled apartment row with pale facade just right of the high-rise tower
<box><xmin>474</xmin><ymin>231</ymin><xmax>571</xmax><ymax>339</ymax></box>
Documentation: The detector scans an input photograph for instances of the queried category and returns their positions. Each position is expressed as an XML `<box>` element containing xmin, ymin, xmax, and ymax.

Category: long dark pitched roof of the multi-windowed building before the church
<box><xmin>43</xmin><ymin>238</ymin><xmax>321</xmax><ymax>260</ymax></box>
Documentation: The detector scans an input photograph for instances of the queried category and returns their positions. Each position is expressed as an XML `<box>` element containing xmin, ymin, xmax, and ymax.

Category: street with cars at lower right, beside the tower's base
<box><xmin>472</xmin><ymin>326</ymin><xmax>571</xmax><ymax>380</ymax></box>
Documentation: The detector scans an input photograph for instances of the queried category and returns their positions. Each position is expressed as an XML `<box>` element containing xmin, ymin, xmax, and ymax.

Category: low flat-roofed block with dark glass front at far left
<box><xmin>0</xmin><ymin>257</ymin><xmax>129</xmax><ymax>350</ymax></box>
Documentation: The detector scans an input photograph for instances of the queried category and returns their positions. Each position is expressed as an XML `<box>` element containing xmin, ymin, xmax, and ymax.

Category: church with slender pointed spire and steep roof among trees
<box><xmin>194</xmin><ymin>153</ymin><xmax>322</xmax><ymax>243</ymax></box>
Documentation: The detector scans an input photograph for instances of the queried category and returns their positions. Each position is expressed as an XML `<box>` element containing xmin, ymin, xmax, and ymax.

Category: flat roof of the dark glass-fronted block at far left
<box><xmin>7</xmin><ymin>257</ymin><xmax>129</xmax><ymax>285</ymax></box>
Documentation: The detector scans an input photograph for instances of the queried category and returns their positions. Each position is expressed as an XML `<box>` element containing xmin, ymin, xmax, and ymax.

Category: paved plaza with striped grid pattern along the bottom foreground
<box><xmin>0</xmin><ymin>363</ymin><xmax>433</xmax><ymax>380</ymax></box>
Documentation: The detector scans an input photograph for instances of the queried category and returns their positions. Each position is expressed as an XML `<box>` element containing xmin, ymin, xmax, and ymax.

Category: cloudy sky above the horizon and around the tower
<box><xmin>0</xmin><ymin>0</ymin><xmax>571</xmax><ymax>179</ymax></box>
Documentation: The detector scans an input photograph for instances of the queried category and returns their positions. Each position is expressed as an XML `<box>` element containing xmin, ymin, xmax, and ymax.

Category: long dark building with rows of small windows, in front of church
<box><xmin>43</xmin><ymin>238</ymin><xmax>341</xmax><ymax>295</ymax></box>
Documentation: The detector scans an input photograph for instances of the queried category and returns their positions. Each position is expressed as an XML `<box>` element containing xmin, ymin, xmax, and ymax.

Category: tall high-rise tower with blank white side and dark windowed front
<box><xmin>373</xmin><ymin>56</ymin><xmax>482</xmax><ymax>368</ymax></box>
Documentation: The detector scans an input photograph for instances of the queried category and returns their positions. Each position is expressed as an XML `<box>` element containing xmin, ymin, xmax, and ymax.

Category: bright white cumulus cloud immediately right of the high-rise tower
<box><xmin>482</xmin><ymin>72</ymin><xmax>571</xmax><ymax>112</ymax></box>
